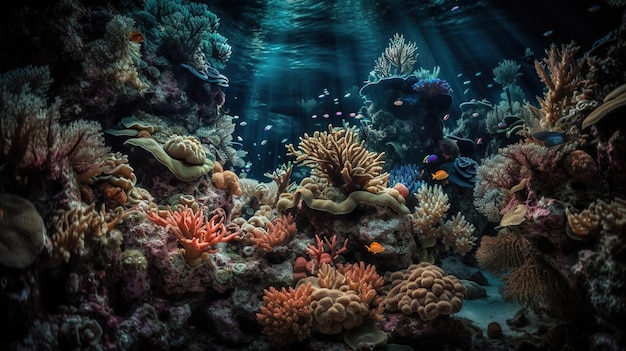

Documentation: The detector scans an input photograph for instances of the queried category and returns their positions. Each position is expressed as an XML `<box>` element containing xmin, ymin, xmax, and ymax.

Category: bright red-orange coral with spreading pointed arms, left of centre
<box><xmin>147</xmin><ymin>206</ymin><xmax>239</xmax><ymax>266</ymax></box>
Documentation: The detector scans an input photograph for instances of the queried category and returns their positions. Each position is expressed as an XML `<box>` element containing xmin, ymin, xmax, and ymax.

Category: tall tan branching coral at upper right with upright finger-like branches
<box><xmin>535</xmin><ymin>42</ymin><xmax>585</xmax><ymax>129</ymax></box>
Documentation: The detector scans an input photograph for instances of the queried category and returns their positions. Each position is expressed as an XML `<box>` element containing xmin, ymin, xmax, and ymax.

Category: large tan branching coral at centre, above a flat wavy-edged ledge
<box><xmin>286</xmin><ymin>125</ymin><xmax>389</xmax><ymax>195</ymax></box>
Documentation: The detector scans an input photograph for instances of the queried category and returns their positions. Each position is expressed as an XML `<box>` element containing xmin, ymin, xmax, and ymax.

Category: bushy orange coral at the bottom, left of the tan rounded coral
<box><xmin>256</xmin><ymin>284</ymin><xmax>313</xmax><ymax>345</ymax></box>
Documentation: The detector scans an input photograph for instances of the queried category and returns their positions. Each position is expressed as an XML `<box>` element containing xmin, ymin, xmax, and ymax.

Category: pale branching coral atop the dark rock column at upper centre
<box><xmin>374</xmin><ymin>33</ymin><xmax>417</xmax><ymax>78</ymax></box>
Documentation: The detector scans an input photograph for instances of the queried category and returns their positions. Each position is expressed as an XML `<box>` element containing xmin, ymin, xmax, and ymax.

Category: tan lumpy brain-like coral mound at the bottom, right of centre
<box><xmin>384</xmin><ymin>262</ymin><xmax>467</xmax><ymax>321</ymax></box>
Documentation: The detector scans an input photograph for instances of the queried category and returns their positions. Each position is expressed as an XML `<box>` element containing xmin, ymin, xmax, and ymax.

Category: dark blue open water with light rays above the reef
<box><xmin>208</xmin><ymin>0</ymin><xmax>622</xmax><ymax>174</ymax></box>
